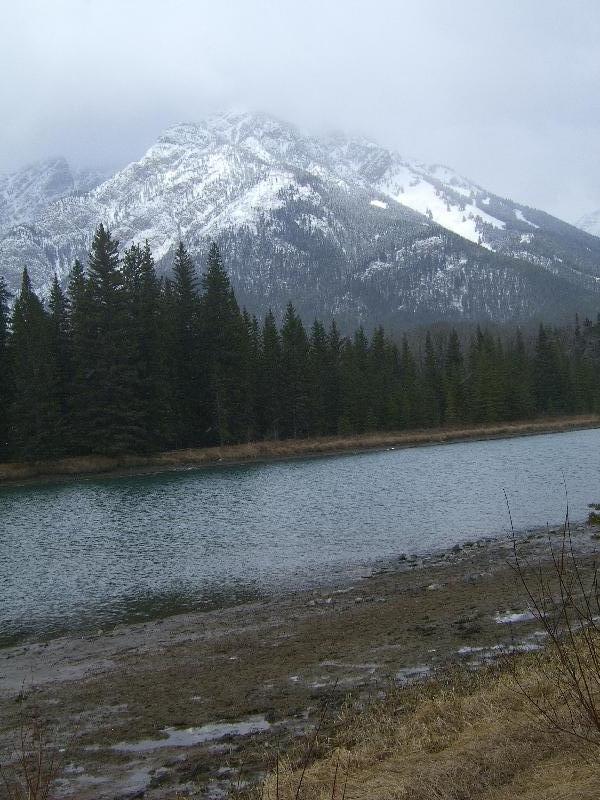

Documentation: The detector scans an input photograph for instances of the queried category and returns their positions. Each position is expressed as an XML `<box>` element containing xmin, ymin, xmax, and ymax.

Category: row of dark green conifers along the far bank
<box><xmin>0</xmin><ymin>225</ymin><xmax>600</xmax><ymax>460</ymax></box>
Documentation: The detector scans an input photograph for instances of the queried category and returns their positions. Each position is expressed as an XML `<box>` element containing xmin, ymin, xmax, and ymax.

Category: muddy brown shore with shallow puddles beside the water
<box><xmin>0</xmin><ymin>524</ymin><xmax>597</xmax><ymax>800</ymax></box>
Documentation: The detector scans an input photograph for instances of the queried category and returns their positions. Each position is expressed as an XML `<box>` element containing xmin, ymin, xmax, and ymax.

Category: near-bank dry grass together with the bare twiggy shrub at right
<box><xmin>256</xmin><ymin>504</ymin><xmax>600</xmax><ymax>800</ymax></box>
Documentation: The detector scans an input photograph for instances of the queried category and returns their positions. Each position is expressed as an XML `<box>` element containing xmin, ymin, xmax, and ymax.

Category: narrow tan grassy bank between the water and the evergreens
<box><xmin>0</xmin><ymin>415</ymin><xmax>600</xmax><ymax>484</ymax></box>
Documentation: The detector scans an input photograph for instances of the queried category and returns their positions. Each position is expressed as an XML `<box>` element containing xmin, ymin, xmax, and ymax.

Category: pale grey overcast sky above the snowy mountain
<box><xmin>0</xmin><ymin>0</ymin><xmax>600</xmax><ymax>221</ymax></box>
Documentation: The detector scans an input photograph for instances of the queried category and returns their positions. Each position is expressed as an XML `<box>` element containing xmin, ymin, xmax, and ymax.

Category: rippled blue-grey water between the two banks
<box><xmin>0</xmin><ymin>430</ymin><xmax>600</xmax><ymax>644</ymax></box>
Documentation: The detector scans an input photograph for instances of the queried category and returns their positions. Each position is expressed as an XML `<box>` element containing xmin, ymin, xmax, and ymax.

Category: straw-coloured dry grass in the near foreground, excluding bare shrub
<box><xmin>255</xmin><ymin>654</ymin><xmax>600</xmax><ymax>800</ymax></box>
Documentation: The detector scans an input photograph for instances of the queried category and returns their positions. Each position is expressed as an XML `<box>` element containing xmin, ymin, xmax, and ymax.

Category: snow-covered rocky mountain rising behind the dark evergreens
<box><xmin>0</xmin><ymin>109</ymin><xmax>600</xmax><ymax>326</ymax></box>
